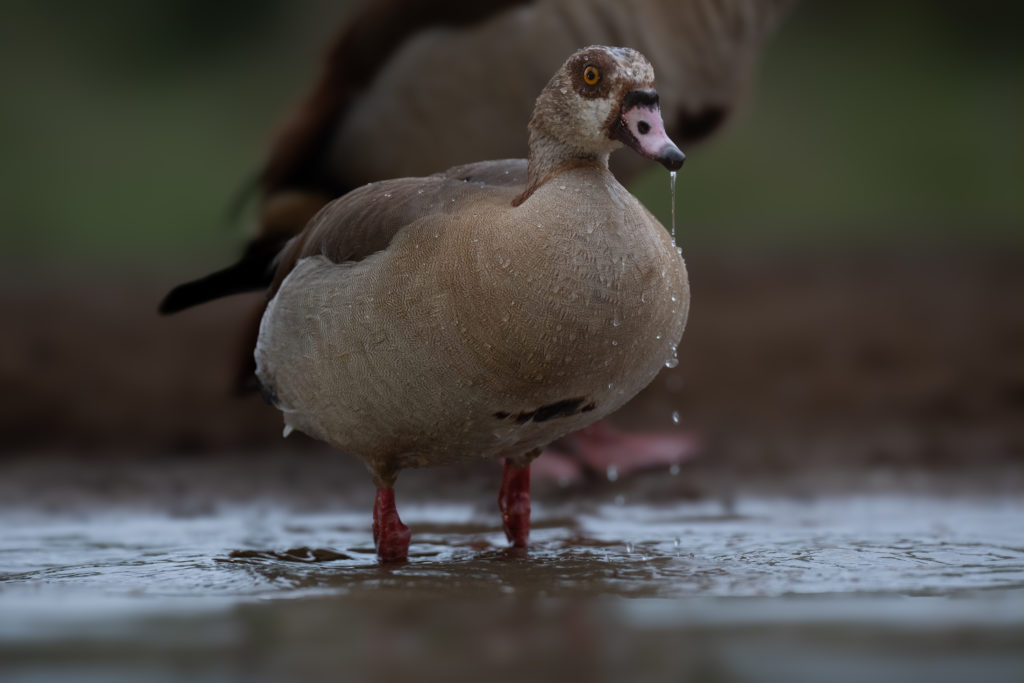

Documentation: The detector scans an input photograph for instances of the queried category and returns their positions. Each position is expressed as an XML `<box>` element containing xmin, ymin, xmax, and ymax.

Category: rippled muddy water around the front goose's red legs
<box><xmin>0</xmin><ymin>466</ymin><xmax>1024</xmax><ymax>681</ymax></box>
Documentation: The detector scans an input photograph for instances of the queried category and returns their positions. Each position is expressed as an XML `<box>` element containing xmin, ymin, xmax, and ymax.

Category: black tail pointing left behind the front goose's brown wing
<box><xmin>160</xmin><ymin>237</ymin><xmax>287</xmax><ymax>315</ymax></box>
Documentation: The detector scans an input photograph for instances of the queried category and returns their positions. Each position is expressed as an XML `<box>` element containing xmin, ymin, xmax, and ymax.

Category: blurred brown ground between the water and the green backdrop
<box><xmin>6</xmin><ymin>249</ymin><xmax>1024</xmax><ymax>485</ymax></box>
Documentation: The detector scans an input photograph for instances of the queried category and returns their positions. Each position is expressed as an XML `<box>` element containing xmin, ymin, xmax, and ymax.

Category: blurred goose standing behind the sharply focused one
<box><xmin>161</xmin><ymin>0</ymin><xmax>793</xmax><ymax>480</ymax></box>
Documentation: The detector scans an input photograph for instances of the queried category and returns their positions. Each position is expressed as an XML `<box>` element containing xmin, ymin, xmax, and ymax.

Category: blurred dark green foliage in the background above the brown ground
<box><xmin>0</xmin><ymin>0</ymin><xmax>1024</xmax><ymax>270</ymax></box>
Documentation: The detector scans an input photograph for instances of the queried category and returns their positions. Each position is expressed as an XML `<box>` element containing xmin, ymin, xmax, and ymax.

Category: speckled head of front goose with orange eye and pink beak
<box><xmin>529</xmin><ymin>46</ymin><xmax>686</xmax><ymax>171</ymax></box>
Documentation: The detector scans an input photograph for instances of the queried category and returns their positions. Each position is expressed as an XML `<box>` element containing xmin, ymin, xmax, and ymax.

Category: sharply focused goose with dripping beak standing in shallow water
<box><xmin>255</xmin><ymin>46</ymin><xmax>689</xmax><ymax>562</ymax></box>
